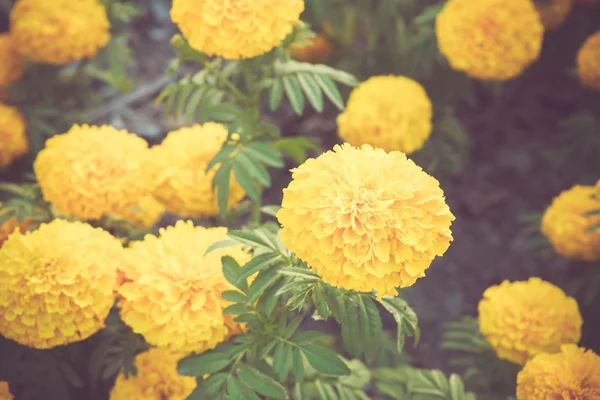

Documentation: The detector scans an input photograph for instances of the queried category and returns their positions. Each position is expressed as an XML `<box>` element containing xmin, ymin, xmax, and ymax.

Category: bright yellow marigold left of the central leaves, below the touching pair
<box><xmin>119</xmin><ymin>221</ymin><xmax>251</xmax><ymax>353</ymax></box>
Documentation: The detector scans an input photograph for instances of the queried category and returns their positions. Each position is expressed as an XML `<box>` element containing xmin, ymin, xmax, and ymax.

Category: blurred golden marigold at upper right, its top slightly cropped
<box><xmin>435</xmin><ymin>0</ymin><xmax>544</xmax><ymax>81</ymax></box>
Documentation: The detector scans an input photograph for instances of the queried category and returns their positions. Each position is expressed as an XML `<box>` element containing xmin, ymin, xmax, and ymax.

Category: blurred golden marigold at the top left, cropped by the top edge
<box><xmin>10</xmin><ymin>0</ymin><xmax>110</xmax><ymax>65</ymax></box>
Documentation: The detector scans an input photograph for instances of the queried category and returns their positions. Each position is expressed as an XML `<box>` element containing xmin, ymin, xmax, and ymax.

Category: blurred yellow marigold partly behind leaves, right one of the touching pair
<box><xmin>151</xmin><ymin>122</ymin><xmax>246</xmax><ymax>217</ymax></box>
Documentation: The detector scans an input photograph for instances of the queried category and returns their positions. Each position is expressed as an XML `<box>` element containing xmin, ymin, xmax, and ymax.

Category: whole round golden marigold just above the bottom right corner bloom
<box><xmin>478</xmin><ymin>278</ymin><xmax>583</xmax><ymax>365</ymax></box>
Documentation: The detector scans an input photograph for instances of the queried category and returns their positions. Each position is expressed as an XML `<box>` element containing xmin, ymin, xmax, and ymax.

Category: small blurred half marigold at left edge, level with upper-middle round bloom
<box><xmin>0</xmin><ymin>103</ymin><xmax>29</xmax><ymax>168</ymax></box>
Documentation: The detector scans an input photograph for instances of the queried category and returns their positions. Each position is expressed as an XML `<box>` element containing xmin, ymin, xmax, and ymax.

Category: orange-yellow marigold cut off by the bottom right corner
<box><xmin>517</xmin><ymin>344</ymin><xmax>600</xmax><ymax>400</ymax></box>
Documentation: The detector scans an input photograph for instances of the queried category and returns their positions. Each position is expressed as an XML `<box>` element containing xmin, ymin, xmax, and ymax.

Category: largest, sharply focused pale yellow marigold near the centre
<box><xmin>277</xmin><ymin>144</ymin><xmax>454</xmax><ymax>296</ymax></box>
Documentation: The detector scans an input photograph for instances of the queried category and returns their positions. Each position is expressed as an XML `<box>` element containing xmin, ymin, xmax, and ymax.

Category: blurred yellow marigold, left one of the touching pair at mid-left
<box><xmin>33</xmin><ymin>125</ymin><xmax>150</xmax><ymax>220</ymax></box>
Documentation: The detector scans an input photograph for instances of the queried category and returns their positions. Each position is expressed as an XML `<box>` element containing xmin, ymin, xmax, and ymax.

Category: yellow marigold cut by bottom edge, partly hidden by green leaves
<box><xmin>109</xmin><ymin>348</ymin><xmax>196</xmax><ymax>400</ymax></box>
